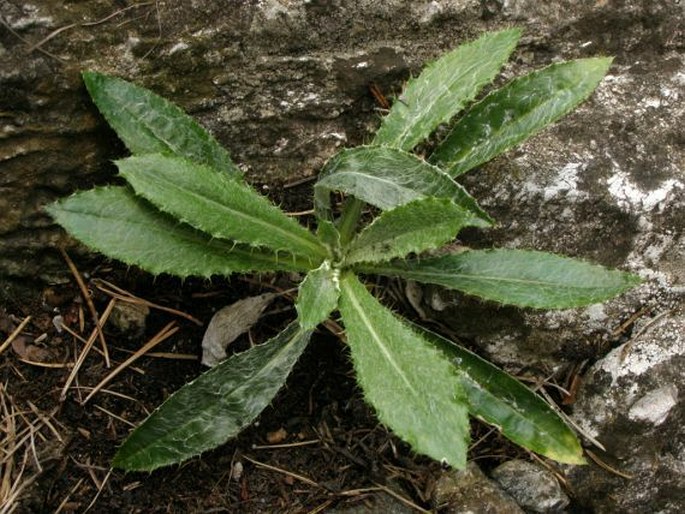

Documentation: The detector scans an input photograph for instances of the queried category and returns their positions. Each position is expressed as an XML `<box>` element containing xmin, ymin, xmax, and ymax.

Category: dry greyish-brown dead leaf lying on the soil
<box><xmin>202</xmin><ymin>293</ymin><xmax>277</xmax><ymax>368</ymax></box>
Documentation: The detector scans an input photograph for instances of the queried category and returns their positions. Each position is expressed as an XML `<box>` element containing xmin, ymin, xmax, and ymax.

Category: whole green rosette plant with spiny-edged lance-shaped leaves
<box><xmin>48</xmin><ymin>29</ymin><xmax>640</xmax><ymax>470</ymax></box>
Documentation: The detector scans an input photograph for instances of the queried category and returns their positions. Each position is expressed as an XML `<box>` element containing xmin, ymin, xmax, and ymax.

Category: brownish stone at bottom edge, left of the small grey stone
<box><xmin>432</xmin><ymin>462</ymin><xmax>523</xmax><ymax>514</ymax></box>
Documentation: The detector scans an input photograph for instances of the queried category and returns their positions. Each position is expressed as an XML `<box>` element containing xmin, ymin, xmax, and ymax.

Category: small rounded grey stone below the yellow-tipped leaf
<box><xmin>491</xmin><ymin>460</ymin><xmax>569</xmax><ymax>513</ymax></box>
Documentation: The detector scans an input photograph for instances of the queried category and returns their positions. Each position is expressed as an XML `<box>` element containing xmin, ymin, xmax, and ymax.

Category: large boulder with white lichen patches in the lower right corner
<box><xmin>568</xmin><ymin>309</ymin><xmax>685</xmax><ymax>514</ymax></box>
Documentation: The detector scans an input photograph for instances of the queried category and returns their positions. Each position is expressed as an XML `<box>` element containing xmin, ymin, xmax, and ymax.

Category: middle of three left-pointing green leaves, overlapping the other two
<box><xmin>117</xmin><ymin>154</ymin><xmax>328</xmax><ymax>262</ymax></box>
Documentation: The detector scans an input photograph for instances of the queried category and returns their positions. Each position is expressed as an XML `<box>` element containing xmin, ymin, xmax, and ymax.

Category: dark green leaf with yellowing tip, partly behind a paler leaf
<box><xmin>408</xmin><ymin>326</ymin><xmax>585</xmax><ymax>464</ymax></box>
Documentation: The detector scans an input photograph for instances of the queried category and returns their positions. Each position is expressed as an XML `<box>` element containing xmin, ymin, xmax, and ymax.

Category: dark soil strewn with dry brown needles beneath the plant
<box><xmin>0</xmin><ymin>261</ymin><xmax>528</xmax><ymax>513</ymax></box>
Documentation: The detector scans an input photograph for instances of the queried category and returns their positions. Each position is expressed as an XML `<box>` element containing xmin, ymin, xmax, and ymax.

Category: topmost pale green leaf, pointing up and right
<box><xmin>373</xmin><ymin>29</ymin><xmax>521</xmax><ymax>150</ymax></box>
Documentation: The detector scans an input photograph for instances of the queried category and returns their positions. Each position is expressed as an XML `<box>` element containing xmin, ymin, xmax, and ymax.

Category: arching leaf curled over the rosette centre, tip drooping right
<box><xmin>314</xmin><ymin>146</ymin><xmax>492</xmax><ymax>222</ymax></box>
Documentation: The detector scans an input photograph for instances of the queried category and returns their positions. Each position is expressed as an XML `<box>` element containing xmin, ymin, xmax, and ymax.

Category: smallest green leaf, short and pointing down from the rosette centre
<box><xmin>295</xmin><ymin>261</ymin><xmax>340</xmax><ymax>330</ymax></box>
